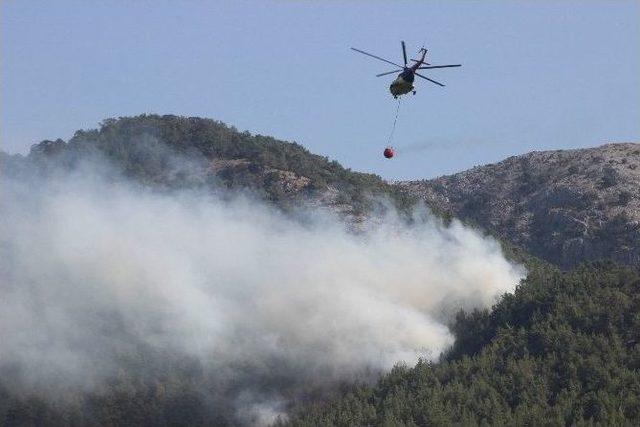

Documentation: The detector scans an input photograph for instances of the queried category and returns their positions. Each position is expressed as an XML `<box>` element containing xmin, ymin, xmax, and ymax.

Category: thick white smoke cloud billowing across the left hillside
<box><xmin>0</xmin><ymin>160</ymin><xmax>523</xmax><ymax>423</ymax></box>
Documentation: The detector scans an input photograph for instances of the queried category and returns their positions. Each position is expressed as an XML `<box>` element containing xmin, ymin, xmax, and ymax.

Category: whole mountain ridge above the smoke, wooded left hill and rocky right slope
<box><xmin>0</xmin><ymin>115</ymin><xmax>640</xmax><ymax>268</ymax></box>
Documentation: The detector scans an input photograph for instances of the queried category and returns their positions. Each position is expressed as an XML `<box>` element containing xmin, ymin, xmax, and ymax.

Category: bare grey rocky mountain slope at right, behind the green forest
<box><xmin>398</xmin><ymin>143</ymin><xmax>640</xmax><ymax>268</ymax></box>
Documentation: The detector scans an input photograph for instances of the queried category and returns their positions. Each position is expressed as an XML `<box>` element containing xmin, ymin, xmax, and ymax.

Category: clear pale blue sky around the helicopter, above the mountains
<box><xmin>0</xmin><ymin>0</ymin><xmax>640</xmax><ymax>179</ymax></box>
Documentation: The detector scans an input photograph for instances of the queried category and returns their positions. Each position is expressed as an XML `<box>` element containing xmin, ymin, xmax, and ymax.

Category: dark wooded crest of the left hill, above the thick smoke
<box><xmin>32</xmin><ymin>115</ymin><xmax>417</xmax><ymax>214</ymax></box>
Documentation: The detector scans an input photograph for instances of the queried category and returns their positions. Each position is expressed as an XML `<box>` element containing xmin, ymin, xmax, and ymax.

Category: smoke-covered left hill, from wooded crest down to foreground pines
<box><xmin>0</xmin><ymin>116</ymin><xmax>523</xmax><ymax>425</ymax></box>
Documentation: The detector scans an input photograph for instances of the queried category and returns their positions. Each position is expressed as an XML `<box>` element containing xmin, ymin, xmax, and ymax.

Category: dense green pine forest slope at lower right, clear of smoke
<box><xmin>291</xmin><ymin>263</ymin><xmax>640</xmax><ymax>426</ymax></box>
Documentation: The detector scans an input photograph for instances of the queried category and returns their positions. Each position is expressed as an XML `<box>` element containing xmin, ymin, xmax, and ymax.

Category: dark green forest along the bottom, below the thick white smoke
<box><xmin>0</xmin><ymin>263</ymin><xmax>640</xmax><ymax>426</ymax></box>
